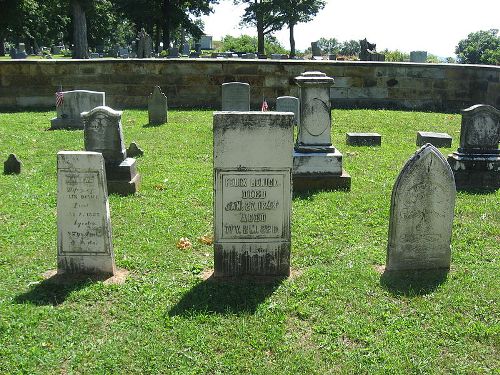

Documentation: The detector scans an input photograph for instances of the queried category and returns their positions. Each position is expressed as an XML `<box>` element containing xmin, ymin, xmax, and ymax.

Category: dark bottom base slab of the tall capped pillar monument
<box><xmin>292</xmin><ymin>169</ymin><xmax>351</xmax><ymax>193</ymax></box>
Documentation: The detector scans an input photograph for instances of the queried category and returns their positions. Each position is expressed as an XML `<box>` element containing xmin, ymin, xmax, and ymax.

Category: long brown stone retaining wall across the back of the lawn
<box><xmin>0</xmin><ymin>59</ymin><xmax>500</xmax><ymax>112</ymax></box>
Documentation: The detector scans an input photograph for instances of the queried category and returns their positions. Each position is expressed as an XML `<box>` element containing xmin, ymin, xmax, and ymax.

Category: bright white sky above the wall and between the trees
<box><xmin>202</xmin><ymin>0</ymin><xmax>500</xmax><ymax>57</ymax></box>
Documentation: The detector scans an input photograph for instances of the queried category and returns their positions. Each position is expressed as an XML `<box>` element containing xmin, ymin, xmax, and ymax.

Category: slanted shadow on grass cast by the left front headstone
<box><xmin>14</xmin><ymin>273</ymin><xmax>109</xmax><ymax>306</ymax></box>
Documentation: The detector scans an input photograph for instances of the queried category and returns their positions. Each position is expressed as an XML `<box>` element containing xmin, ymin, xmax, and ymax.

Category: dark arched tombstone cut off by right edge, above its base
<box><xmin>458</xmin><ymin>104</ymin><xmax>500</xmax><ymax>153</ymax></box>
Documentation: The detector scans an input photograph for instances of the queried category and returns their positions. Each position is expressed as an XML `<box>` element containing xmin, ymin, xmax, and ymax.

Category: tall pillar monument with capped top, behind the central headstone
<box><xmin>293</xmin><ymin>72</ymin><xmax>351</xmax><ymax>192</ymax></box>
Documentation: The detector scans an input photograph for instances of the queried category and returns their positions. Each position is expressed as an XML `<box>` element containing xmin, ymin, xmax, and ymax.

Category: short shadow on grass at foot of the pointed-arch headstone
<box><xmin>380</xmin><ymin>269</ymin><xmax>449</xmax><ymax>297</ymax></box>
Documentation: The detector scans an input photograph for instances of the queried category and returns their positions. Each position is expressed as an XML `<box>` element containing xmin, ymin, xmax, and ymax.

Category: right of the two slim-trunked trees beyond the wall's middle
<box><xmin>274</xmin><ymin>0</ymin><xmax>325</xmax><ymax>57</ymax></box>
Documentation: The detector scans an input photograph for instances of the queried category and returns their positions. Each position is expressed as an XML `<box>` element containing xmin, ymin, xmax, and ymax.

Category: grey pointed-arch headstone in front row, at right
<box><xmin>386</xmin><ymin>144</ymin><xmax>456</xmax><ymax>271</ymax></box>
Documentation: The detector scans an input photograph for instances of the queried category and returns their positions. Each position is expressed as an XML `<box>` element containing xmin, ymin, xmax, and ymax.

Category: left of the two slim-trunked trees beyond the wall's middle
<box><xmin>234</xmin><ymin>0</ymin><xmax>285</xmax><ymax>54</ymax></box>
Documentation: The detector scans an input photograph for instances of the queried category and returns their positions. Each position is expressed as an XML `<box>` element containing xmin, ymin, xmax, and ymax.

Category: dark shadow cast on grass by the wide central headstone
<box><xmin>167</xmin><ymin>276</ymin><xmax>286</xmax><ymax>316</ymax></box>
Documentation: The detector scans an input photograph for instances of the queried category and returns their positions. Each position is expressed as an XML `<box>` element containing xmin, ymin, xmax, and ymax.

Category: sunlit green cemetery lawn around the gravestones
<box><xmin>0</xmin><ymin>110</ymin><xmax>500</xmax><ymax>374</ymax></box>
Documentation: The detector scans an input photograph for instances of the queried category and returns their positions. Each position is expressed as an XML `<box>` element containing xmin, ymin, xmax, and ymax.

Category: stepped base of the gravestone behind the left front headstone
<box><xmin>106</xmin><ymin>158</ymin><xmax>141</xmax><ymax>195</ymax></box>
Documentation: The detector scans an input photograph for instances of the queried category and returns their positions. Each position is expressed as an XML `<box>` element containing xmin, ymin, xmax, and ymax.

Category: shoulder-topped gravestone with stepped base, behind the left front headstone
<box><xmin>82</xmin><ymin>106</ymin><xmax>141</xmax><ymax>195</ymax></box>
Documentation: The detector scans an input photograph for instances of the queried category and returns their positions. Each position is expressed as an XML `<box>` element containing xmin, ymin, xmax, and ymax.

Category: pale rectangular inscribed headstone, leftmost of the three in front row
<box><xmin>57</xmin><ymin>151</ymin><xmax>115</xmax><ymax>275</ymax></box>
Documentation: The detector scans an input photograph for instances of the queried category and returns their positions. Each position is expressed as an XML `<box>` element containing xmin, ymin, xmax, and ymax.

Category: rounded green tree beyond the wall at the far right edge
<box><xmin>455</xmin><ymin>29</ymin><xmax>500</xmax><ymax>65</ymax></box>
